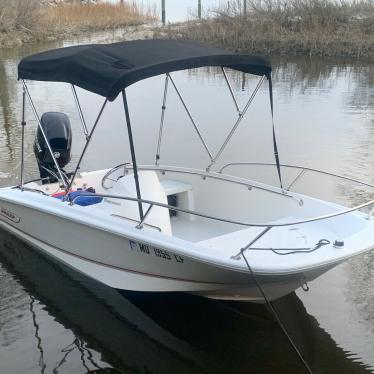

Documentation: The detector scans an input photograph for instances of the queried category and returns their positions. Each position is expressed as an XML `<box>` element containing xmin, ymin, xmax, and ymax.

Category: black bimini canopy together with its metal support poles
<box><xmin>18</xmin><ymin>40</ymin><xmax>283</xmax><ymax>219</ymax></box>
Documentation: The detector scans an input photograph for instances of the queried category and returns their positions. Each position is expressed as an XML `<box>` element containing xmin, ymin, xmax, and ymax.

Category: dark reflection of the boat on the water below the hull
<box><xmin>0</xmin><ymin>232</ymin><xmax>365</xmax><ymax>373</ymax></box>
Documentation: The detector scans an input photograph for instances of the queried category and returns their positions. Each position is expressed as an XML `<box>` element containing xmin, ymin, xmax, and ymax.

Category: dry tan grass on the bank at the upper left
<box><xmin>0</xmin><ymin>0</ymin><xmax>155</xmax><ymax>45</ymax></box>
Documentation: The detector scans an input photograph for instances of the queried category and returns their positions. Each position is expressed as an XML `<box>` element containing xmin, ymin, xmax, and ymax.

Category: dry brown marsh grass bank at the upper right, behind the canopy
<box><xmin>164</xmin><ymin>0</ymin><xmax>374</xmax><ymax>58</ymax></box>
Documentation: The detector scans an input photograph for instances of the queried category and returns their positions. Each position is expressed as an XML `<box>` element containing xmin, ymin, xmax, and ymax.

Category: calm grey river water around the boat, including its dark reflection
<box><xmin>0</xmin><ymin>30</ymin><xmax>374</xmax><ymax>374</ymax></box>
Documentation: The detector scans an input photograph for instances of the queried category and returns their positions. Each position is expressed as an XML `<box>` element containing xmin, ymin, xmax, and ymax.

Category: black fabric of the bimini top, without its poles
<box><xmin>18</xmin><ymin>39</ymin><xmax>271</xmax><ymax>101</ymax></box>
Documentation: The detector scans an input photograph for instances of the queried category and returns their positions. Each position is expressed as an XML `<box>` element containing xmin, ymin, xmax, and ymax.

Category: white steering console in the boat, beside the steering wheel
<box><xmin>103</xmin><ymin>171</ymin><xmax>172</xmax><ymax>235</ymax></box>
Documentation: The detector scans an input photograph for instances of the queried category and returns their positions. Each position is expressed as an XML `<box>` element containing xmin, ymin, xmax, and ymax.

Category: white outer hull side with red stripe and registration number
<box><xmin>0</xmin><ymin>189</ymin><xmax>366</xmax><ymax>302</ymax></box>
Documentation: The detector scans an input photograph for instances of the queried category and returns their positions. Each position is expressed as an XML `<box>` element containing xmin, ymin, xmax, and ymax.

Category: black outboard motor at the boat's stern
<box><xmin>34</xmin><ymin>112</ymin><xmax>72</xmax><ymax>184</ymax></box>
